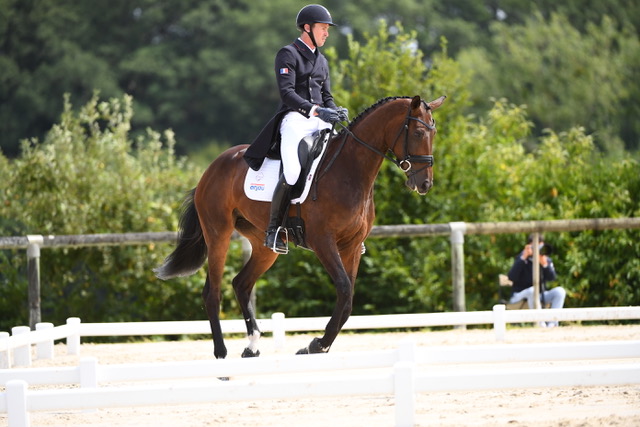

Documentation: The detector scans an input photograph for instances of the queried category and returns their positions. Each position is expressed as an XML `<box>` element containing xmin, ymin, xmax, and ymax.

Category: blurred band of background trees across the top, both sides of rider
<box><xmin>0</xmin><ymin>0</ymin><xmax>640</xmax><ymax>160</ymax></box>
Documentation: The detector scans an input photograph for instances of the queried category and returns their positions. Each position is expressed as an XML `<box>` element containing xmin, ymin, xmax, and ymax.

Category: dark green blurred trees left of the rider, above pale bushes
<box><xmin>0</xmin><ymin>0</ymin><xmax>299</xmax><ymax>156</ymax></box>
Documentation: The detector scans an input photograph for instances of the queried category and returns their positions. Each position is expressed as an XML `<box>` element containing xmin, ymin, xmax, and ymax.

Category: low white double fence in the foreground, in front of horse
<box><xmin>0</xmin><ymin>341</ymin><xmax>640</xmax><ymax>427</ymax></box>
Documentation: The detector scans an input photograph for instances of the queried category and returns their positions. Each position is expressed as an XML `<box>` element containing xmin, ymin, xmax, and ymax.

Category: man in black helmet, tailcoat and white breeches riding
<box><xmin>244</xmin><ymin>4</ymin><xmax>348</xmax><ymax>254</ymax></box>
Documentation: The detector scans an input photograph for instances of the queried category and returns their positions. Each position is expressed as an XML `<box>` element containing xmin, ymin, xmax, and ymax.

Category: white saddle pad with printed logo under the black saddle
<box><xmin>244</xmin><ymin>138</ymin><xmax>329</xmax><ymax>204</ymax></box>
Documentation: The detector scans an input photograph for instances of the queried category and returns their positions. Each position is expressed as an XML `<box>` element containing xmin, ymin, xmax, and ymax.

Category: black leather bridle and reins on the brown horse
<box><xmin>325</xmin><ymin>101</ymin><xmax>436</xmax><ymax>177</ymax></box>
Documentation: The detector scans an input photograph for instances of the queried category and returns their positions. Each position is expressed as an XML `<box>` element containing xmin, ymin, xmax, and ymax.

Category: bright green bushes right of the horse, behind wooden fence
<box><xmin>358</xmin><ymin>95</ymin><xmax>640</xmax><ymax>311</ymax></box>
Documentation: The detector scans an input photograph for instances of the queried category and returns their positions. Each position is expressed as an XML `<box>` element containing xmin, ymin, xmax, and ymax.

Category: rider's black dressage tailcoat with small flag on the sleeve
<box><xmin>244</xmin><ymin>39</ymin><xmax>337</xmax><ymax>170</ymax></box>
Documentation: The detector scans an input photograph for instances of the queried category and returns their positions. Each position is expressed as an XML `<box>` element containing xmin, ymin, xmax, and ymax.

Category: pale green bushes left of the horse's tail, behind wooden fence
<box><xmin>0</xmin><ymin>95</ymin><xmax>215</xmax><ymax>329</ymax></box>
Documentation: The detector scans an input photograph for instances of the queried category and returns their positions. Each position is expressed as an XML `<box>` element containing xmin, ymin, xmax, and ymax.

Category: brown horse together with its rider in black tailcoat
<box><xmin>154</xmin><ymin>5</ymin><xmax>446</xmax><ymax>359</ymax></box>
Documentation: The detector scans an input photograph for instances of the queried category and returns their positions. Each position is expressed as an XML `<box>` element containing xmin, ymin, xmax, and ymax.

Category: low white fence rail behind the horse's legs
<box><xmin>0</xmin><ymin>304</ymin><xmax>640</xmax><ymax>368</ymax></box>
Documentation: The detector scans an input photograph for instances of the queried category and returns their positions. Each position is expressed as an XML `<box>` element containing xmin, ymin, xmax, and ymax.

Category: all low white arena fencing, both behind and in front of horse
<box><xmin>0</xmin><ymin>306</ymin><xmax>640</xmax><ymax>427</ymax></box>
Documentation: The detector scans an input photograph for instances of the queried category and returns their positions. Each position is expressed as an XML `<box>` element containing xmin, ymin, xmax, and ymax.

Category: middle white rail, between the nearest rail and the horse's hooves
<box><xmin>0</xmin><ymin>340</ymin><xmax>640</xmax><ymax>390</ymax></box>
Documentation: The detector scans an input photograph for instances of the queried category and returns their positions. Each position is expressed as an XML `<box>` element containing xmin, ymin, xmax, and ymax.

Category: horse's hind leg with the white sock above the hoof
<box><xmin>232</xmin><ymin>236</ymin><xmax>278</xmax><ymax>357</ymax></box>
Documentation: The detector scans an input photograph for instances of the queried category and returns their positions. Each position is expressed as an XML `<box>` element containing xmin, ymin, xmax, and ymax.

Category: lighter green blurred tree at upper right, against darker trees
<box><xmin>459</xmin><ymin>13</ymin><xmax>640</xmax><ymax>153</ymax></box>
